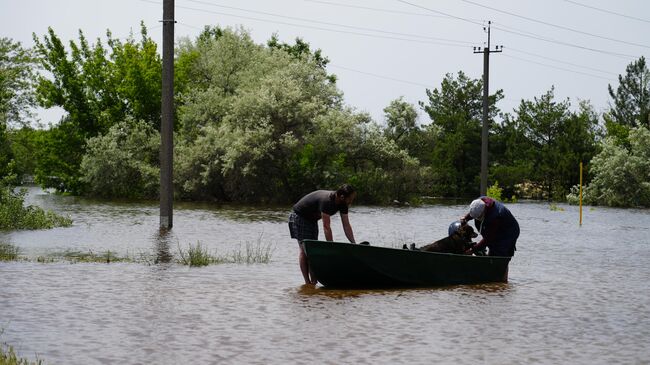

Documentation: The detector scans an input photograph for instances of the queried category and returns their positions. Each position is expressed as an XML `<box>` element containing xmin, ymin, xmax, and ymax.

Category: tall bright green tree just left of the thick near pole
<box><xmin>34</xmin><ymin>26</ymin><xmax>162</xmax><ymax>193</ymax></box>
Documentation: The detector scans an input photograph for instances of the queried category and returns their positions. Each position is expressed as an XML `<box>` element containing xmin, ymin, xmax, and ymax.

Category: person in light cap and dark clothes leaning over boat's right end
<box><xmin>460</xmin><ymin>196</ymin><xmax>519</xmax><ymax>257</ymax></box>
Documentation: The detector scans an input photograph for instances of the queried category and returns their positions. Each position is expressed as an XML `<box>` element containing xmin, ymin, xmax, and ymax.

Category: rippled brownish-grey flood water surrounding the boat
<box><xmin>0</xmin><ymin>189</ymin><xmax>650</xmax><ymax>364</ymax></box>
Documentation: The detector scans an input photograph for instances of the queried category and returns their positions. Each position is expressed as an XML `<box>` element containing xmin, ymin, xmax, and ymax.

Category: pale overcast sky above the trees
<box><xmin>0</xmin><ymin>0</ymin><xmax>650</xmax><ymax>123</ymax></box>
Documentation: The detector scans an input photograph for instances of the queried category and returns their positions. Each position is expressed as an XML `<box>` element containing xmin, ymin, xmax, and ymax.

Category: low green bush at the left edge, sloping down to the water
<box><xmin>0</xmin><ymin>185</ymin><xmax>72</xmax><ymax>230</ymax></box>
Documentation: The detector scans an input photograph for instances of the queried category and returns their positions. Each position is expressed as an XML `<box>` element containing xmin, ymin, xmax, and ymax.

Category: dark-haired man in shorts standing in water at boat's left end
<box><xmin>289</xmin><ymin>184</ymin><xmax>357</xmax><ymax>285</ymax></box>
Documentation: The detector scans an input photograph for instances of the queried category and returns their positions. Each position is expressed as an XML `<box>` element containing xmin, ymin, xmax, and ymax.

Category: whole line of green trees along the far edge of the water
<box><xmin>0</xmin><ymin>25</ymin><xmax>650</xmax><ymax>207</ymax></box>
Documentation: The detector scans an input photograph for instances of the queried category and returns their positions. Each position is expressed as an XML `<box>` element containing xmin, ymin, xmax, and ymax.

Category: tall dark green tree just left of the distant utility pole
<box><xmin>420</xmin><ymin>71</ymin><xmax>503</xmax><ymax>196</ymax></box>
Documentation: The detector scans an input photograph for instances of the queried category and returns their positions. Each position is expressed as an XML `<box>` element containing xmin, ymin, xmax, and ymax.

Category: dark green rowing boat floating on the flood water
<box><xmin>304</xmin><ymin>240</ymin><xmax>510</xmax><ymax>288</ymax></box>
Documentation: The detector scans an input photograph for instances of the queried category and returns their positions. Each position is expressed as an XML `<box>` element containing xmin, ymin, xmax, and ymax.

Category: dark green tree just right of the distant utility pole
<box><xmin>491</xmin><ymin>88</ymin><xmax>600</xmax><ymax>200</ymax></box>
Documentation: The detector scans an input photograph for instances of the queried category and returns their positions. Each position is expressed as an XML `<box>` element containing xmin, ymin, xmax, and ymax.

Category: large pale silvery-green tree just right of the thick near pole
<box><xmin>176</xmin><ymin>29</ymin><xmax>341</xmax><ymax>201</ymax></box>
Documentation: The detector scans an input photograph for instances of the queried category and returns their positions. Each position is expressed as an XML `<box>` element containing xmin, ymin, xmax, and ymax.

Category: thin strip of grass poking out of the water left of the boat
<box><xmin>0</xmin><ymin>240</ymin><xmax>274</xmax><ymax>267</ymax></box>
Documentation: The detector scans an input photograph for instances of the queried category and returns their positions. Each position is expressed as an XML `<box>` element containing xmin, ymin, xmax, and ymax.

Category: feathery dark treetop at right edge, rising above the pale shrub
<box><xmin>608</xmin><ymin>57</ymin><xmax>650</xmax><ymax>128</ymax></box>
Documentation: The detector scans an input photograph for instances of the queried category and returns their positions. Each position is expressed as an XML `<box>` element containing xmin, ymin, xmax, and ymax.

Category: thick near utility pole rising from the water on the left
<box><xmin>160</xmin><ymin>0</ymin><xmax>176</xmax><ymax>229</ymax></box>
